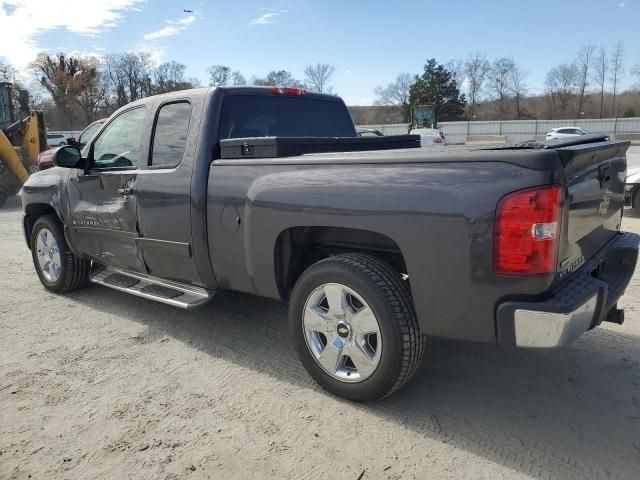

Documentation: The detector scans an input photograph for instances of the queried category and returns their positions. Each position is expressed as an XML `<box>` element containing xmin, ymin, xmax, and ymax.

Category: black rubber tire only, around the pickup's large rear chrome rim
<box><xmin>289</xmin><ymin>254</ymin><xmax>425</xmax><ymax>402</ymax></box>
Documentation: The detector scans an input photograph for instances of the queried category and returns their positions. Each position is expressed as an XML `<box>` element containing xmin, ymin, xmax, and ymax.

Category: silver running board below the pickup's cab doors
<box><xmin>89</xmin><ymin>263</ymin><xmax>216</xmax><ymax>310</ymax></box>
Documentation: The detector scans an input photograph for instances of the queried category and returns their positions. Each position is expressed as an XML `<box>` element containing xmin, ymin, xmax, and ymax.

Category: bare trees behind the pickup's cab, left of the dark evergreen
<box><xmin>0</xmin><ymin>52</ymin><xmax>335</xmax><ymax>130</ymax></box>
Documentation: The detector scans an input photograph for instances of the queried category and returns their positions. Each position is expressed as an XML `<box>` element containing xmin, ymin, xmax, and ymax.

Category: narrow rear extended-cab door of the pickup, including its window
<box><xmin>130</xmin><ymin>98</ymin><xmax>204</xmax><ymax>284</ymax></box>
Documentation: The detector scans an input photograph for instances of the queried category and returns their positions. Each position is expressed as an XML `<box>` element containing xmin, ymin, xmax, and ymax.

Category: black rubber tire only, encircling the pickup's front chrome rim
<box><xmin>30</xmin><ymin>214</ymin><xmax>91</xmax><ymax>293</ymax></box>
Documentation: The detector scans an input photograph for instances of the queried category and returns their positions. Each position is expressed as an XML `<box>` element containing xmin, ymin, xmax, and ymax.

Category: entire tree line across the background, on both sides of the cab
<box><xmin>0</xmin><ymin>42</ymin><xmax>640</xmax><ymax>129</ymax></box>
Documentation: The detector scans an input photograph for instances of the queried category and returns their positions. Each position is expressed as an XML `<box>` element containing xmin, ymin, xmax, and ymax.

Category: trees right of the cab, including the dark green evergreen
<box><xmin>374</xmin><ymin>42</ymin><xmax>640</xmax><ymax>120</ymax></box>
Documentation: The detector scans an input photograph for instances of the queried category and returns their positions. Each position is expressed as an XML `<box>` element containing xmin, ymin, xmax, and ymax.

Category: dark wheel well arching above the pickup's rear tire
<box><xmin>274</xmin><ymin>227</ymin><xmax>407</xmax><ymax>299</ymax></box>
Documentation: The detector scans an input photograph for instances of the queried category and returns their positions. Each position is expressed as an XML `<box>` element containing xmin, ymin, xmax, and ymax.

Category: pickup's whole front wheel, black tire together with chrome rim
<box><xmin>31</xmin><ymin>215</ymin><xmax>90</xmax><ymax>293</ymax></box>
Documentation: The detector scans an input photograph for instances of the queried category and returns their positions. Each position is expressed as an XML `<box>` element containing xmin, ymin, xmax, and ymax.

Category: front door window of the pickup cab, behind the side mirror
<box><xmin>92</xmin><ymin>107</ymin><xmax>146</xmax><ymax>168</ymax></box>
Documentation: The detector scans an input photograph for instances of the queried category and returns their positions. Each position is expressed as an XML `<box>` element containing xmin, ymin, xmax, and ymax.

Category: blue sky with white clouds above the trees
<box><xmin>0</xmin><ymin>0</ymin><xmax>640</xmax><ymax>105</ymax></box>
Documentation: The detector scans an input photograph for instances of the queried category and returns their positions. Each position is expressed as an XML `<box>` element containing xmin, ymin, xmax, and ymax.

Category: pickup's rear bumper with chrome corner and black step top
<box><xmin>496</xmin><ymin>233</ymin><xmax>640</xmax><ymax>348</ymax></box>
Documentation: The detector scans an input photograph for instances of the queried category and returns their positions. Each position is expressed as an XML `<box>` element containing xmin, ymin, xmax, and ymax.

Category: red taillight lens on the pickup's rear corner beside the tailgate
<box><xmin>493</xmin><ymin>185</ymin><xmax>562</xmax><ymax>275</ymax></box>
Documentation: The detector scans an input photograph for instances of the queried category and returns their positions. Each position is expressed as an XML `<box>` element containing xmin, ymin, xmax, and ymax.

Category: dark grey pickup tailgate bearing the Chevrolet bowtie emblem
<box><xmin>557</xmin><ymin>142</ymin><xmax>629</xmax><ymax>278</ymax></box>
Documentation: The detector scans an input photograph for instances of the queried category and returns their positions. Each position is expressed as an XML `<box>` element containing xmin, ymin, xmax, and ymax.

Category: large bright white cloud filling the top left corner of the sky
<box><xmin>0</xmin><ymin>0</ymin><xmax>145</xmax><ymax>71</ymax></box>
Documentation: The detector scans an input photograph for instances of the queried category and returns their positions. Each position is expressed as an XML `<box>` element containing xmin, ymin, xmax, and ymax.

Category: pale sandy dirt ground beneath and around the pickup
<box><xmin>0</xmin><ymin>189</ymin><xmax>640</xmax><ymax>480</ymax></box>
